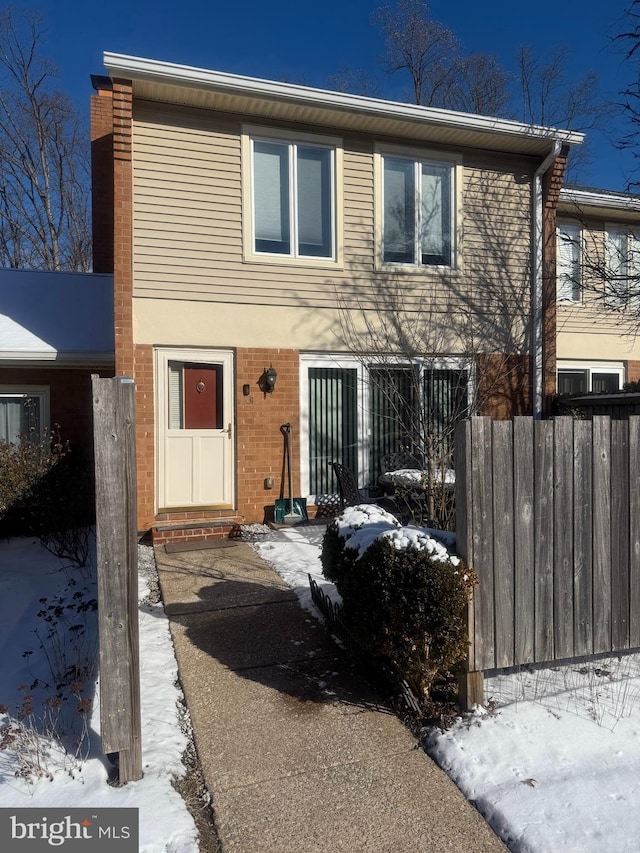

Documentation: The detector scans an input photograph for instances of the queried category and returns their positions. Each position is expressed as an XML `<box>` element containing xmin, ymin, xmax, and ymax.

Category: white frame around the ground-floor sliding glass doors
<box><xmin>300</xmin><ymin>353</ymin><xmax>476</xmax><ymax>504</ymax></box>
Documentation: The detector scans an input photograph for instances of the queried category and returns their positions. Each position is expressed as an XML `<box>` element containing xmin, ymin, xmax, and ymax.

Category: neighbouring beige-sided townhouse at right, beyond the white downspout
<box><xmin>557</xmin><ymin>187</ymin><xmax>640</xmax><ymax>394</ymax></box>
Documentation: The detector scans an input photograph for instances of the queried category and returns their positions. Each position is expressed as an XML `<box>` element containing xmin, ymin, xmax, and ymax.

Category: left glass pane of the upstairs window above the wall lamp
<box><xmin>253</xmin><ymin>141</ymin><xmax>291</xmax><ymax>255</ymax></box>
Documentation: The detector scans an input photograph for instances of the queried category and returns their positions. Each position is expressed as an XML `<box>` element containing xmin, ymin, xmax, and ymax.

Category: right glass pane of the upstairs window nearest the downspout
<box><xmin>420</xmin><ymin>163</ymin><xmax>451</xmax><ymax>266</ymax></box>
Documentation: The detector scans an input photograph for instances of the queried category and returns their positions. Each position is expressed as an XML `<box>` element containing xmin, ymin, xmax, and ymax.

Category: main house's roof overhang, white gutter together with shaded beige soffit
<box><xmin>104</xmin><ymin>52</ymin><xmax>584</xmax><ymax>156</ymax></box>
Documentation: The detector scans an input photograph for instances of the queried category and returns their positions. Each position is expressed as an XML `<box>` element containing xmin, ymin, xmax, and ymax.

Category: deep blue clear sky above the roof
<box><xmin>23</xmin><ymin>0</ymin><xmax>633</xmax><ymax>190</ymax></box>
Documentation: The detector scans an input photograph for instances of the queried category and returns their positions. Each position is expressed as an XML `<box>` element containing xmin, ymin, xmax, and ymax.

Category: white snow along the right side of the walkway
<box><xmin>253</xmin><ymin>527</ymin><xmax>640</xmax><ymax>853</ymax></box>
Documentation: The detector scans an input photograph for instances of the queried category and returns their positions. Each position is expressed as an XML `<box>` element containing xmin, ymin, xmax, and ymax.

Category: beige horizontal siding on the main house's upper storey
<box><xmin>133</xmin><ymin>102</ymin><xmax>533</xmax><ymax>349</ymax></box>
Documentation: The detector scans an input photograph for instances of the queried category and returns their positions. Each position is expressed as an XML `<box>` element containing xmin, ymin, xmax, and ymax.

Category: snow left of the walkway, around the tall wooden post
<box><xmin>0</xmin><ymin>538</ymin><xmax>198</xmax><ymax>853</ymax></box>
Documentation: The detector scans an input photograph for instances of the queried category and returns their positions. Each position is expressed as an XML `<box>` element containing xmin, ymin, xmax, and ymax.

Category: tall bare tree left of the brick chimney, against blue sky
<box><xmin>0</xmin><ymin>7</ymin><xmax>91</xmax><ymax>271</ymax></box>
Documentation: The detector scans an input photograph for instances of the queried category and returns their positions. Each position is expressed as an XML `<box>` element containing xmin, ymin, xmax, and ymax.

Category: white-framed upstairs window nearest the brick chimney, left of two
<box><xmin>245</xmin><ymin>129</ymin><xmax>339</xmax><ymax>262</ymax></box>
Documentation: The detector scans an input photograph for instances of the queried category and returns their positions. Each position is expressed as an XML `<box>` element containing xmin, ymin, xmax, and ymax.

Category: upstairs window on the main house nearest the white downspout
<box><xmin>382</xmin><ymin>154</ymin><xmax>455</xmax><ymax>267</ymax></box>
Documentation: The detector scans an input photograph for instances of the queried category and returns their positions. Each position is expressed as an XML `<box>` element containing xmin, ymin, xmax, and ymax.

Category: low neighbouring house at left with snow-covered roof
<box><xmin>0</xmin><ymin>269</ymin><xmax>114</xmax><ymax>459</ymax></box>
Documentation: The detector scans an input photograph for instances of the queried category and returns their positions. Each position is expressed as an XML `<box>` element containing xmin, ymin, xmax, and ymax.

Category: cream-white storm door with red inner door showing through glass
<box><xmin>156</xmin><ymin>350</ymin><xmax>235</xmax><ymax>511</ymax></box>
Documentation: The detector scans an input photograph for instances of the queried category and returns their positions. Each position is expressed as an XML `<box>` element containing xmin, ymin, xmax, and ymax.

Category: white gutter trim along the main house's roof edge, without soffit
<box><xmin>103</xmin><ymin>51</ymin><xmax>584</xmax><ymax>145</ymax></box>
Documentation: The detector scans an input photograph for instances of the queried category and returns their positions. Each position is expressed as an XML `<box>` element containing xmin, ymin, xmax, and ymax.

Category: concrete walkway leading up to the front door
<box><xmin>156</xmin><ymin>540</ymin><xmax>506</xmax><ymax>853</ymax></box>
